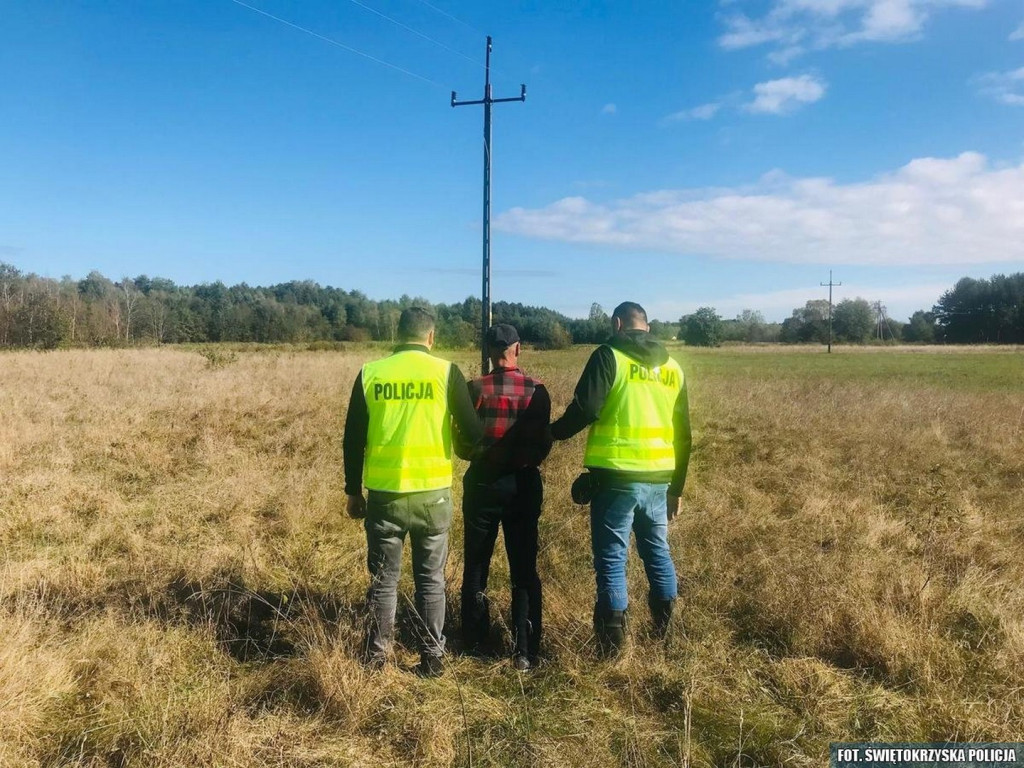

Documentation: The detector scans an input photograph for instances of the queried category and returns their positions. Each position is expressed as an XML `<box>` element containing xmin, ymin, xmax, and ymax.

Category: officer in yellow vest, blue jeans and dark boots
<box><xmin>551</xmin><ymin>301</ymin><xmax>690</xmax><ymax>654</ymax></box>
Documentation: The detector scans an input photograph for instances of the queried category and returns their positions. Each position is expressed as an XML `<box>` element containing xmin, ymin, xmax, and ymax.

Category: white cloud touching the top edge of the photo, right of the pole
<box><xmin>718</xmin><ymin>0</ymin><xmax>987</xmax><ymax>63</ymax></box>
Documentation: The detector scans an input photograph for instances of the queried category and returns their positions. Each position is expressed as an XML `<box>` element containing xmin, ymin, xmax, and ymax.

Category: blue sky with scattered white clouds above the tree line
<box><xmin>0</xmin><ymin>0</ymin><xmax>1024</xmax><ymax>319</ymax></box>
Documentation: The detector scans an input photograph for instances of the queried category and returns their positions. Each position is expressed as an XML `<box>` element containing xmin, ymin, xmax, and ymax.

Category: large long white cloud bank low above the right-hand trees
<box><xmin>496</xmin><ymin>153</ymin><xmax>1024</xmax><ymax>266</ymax></box>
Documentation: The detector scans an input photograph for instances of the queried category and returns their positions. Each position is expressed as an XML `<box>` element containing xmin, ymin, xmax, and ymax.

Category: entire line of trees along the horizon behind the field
<box><xmin>0</xmin><ymin>262</ymin><xmax>1024</xmax><ymax>349</ymax></box>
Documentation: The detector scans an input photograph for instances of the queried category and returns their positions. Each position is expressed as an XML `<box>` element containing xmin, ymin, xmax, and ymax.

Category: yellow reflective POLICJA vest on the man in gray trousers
<box><xmin>362</xmin><ymin>350</ymin><xmax>452</xmax><ymax>494</ymax></box>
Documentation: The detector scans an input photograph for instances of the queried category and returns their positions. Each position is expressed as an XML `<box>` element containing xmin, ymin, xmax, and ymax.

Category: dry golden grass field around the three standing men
<box><xmin>0</xmin><ymin>348</ymin><xmax>1024</xmax><ymax>768</ymax></box>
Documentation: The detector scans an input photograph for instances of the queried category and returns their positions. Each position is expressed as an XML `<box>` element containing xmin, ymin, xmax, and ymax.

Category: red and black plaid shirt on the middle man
<box><xmin>469</xmin><ymin>368</ymin><xmax>551</xmax><ymax>475</ymax></box>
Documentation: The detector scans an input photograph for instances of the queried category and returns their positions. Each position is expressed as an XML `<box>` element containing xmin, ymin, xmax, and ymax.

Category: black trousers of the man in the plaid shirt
<box><xmin>462</xmin><ymin>467</ymin><xmax>544</xmax><ymax>657</ymax></box>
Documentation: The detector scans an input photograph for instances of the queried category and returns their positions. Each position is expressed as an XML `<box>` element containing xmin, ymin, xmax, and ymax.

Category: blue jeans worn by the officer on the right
<box><xmin>590</xmin><ymin>479</ymin><xmax>677</xmax><ymax>610</ymax></box>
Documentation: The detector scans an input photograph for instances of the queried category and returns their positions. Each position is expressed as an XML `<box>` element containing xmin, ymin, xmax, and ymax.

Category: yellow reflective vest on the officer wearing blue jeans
<box><xmin>584</xmin><ymin>347</ymin><xmax>684</xmax><ymax>472</ymax></box>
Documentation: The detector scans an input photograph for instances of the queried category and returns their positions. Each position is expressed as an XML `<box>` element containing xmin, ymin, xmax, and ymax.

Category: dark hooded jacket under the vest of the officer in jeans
<box><xmin>551</xmin><ymin>331</ymin><xmax>692</xmax><ymax>496</ymax></box>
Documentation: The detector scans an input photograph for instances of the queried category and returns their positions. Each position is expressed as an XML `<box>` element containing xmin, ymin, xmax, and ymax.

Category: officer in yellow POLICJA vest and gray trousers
<box><xmin>344</xmin><ymin>307</ymin><xmax>483</xmax><ymax>677</ymax></box>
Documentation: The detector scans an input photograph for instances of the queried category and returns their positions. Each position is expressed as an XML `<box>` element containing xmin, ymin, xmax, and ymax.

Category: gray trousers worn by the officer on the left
<box><xmin>364</xmin><ymin>488</ymin><xmax>452</xmax><ymax>658</ymax></box>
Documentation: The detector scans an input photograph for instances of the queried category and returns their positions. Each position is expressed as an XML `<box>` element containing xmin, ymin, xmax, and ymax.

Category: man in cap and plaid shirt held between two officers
<box><xmin>462</xmin><ymin>324</ymin><xmax>551</xmax><ymax>672</ymax></box>
